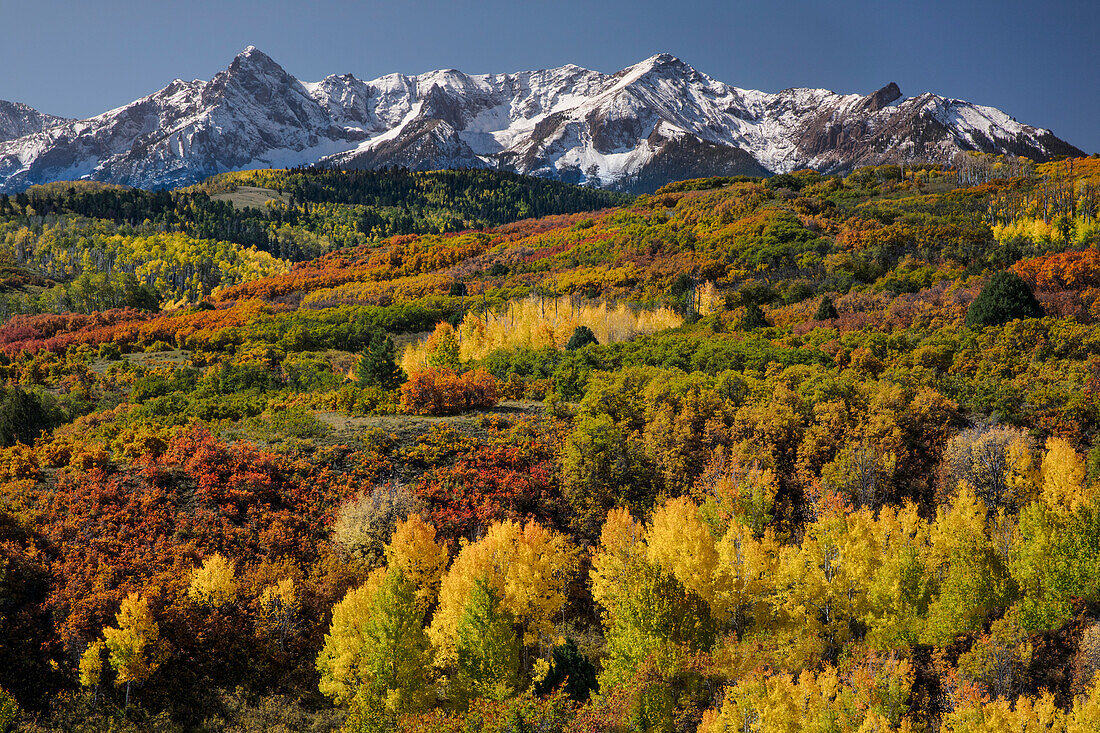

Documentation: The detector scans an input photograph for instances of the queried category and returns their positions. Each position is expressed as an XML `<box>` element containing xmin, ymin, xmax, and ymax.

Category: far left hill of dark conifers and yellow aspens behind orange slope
<box><xmin>0</xmin><ymin>169</ymin><xmax>629</xmax><ymax>319</ymax></box>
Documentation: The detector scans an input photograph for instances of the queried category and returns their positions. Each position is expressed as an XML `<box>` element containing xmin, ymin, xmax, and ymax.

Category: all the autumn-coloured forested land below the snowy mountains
<box><xmin>0</xmin><ymin>155</ymin><xmax>1100</xmax><ymax>733</ymax></box>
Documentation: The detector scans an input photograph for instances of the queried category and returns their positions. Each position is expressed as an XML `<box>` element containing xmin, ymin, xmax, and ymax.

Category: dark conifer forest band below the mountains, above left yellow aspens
<box><xmin>0</xmin><ymin>168</ymin><xmax>629</xmax><ymax>261</ymax></box>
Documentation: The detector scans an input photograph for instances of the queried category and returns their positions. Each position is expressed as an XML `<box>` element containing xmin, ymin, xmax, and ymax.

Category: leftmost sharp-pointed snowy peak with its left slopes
<box><xmin>0</xmin><ymin>47</ymin><xmax>363</xmax><ymax>190</ymax></box>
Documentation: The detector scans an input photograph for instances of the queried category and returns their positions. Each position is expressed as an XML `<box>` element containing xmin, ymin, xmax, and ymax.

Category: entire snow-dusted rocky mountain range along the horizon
<box><xmin>0</xmin><ymin>46</ymin><xmax>1082</xmax><ymax>192</ymax></box>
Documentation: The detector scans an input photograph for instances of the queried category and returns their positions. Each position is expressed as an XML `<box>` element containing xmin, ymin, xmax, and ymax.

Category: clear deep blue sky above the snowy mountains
<box><xmin>0</xmin><ymin>0</ymin><xmax>1100</xmax><ymax>153</ymax></box>
